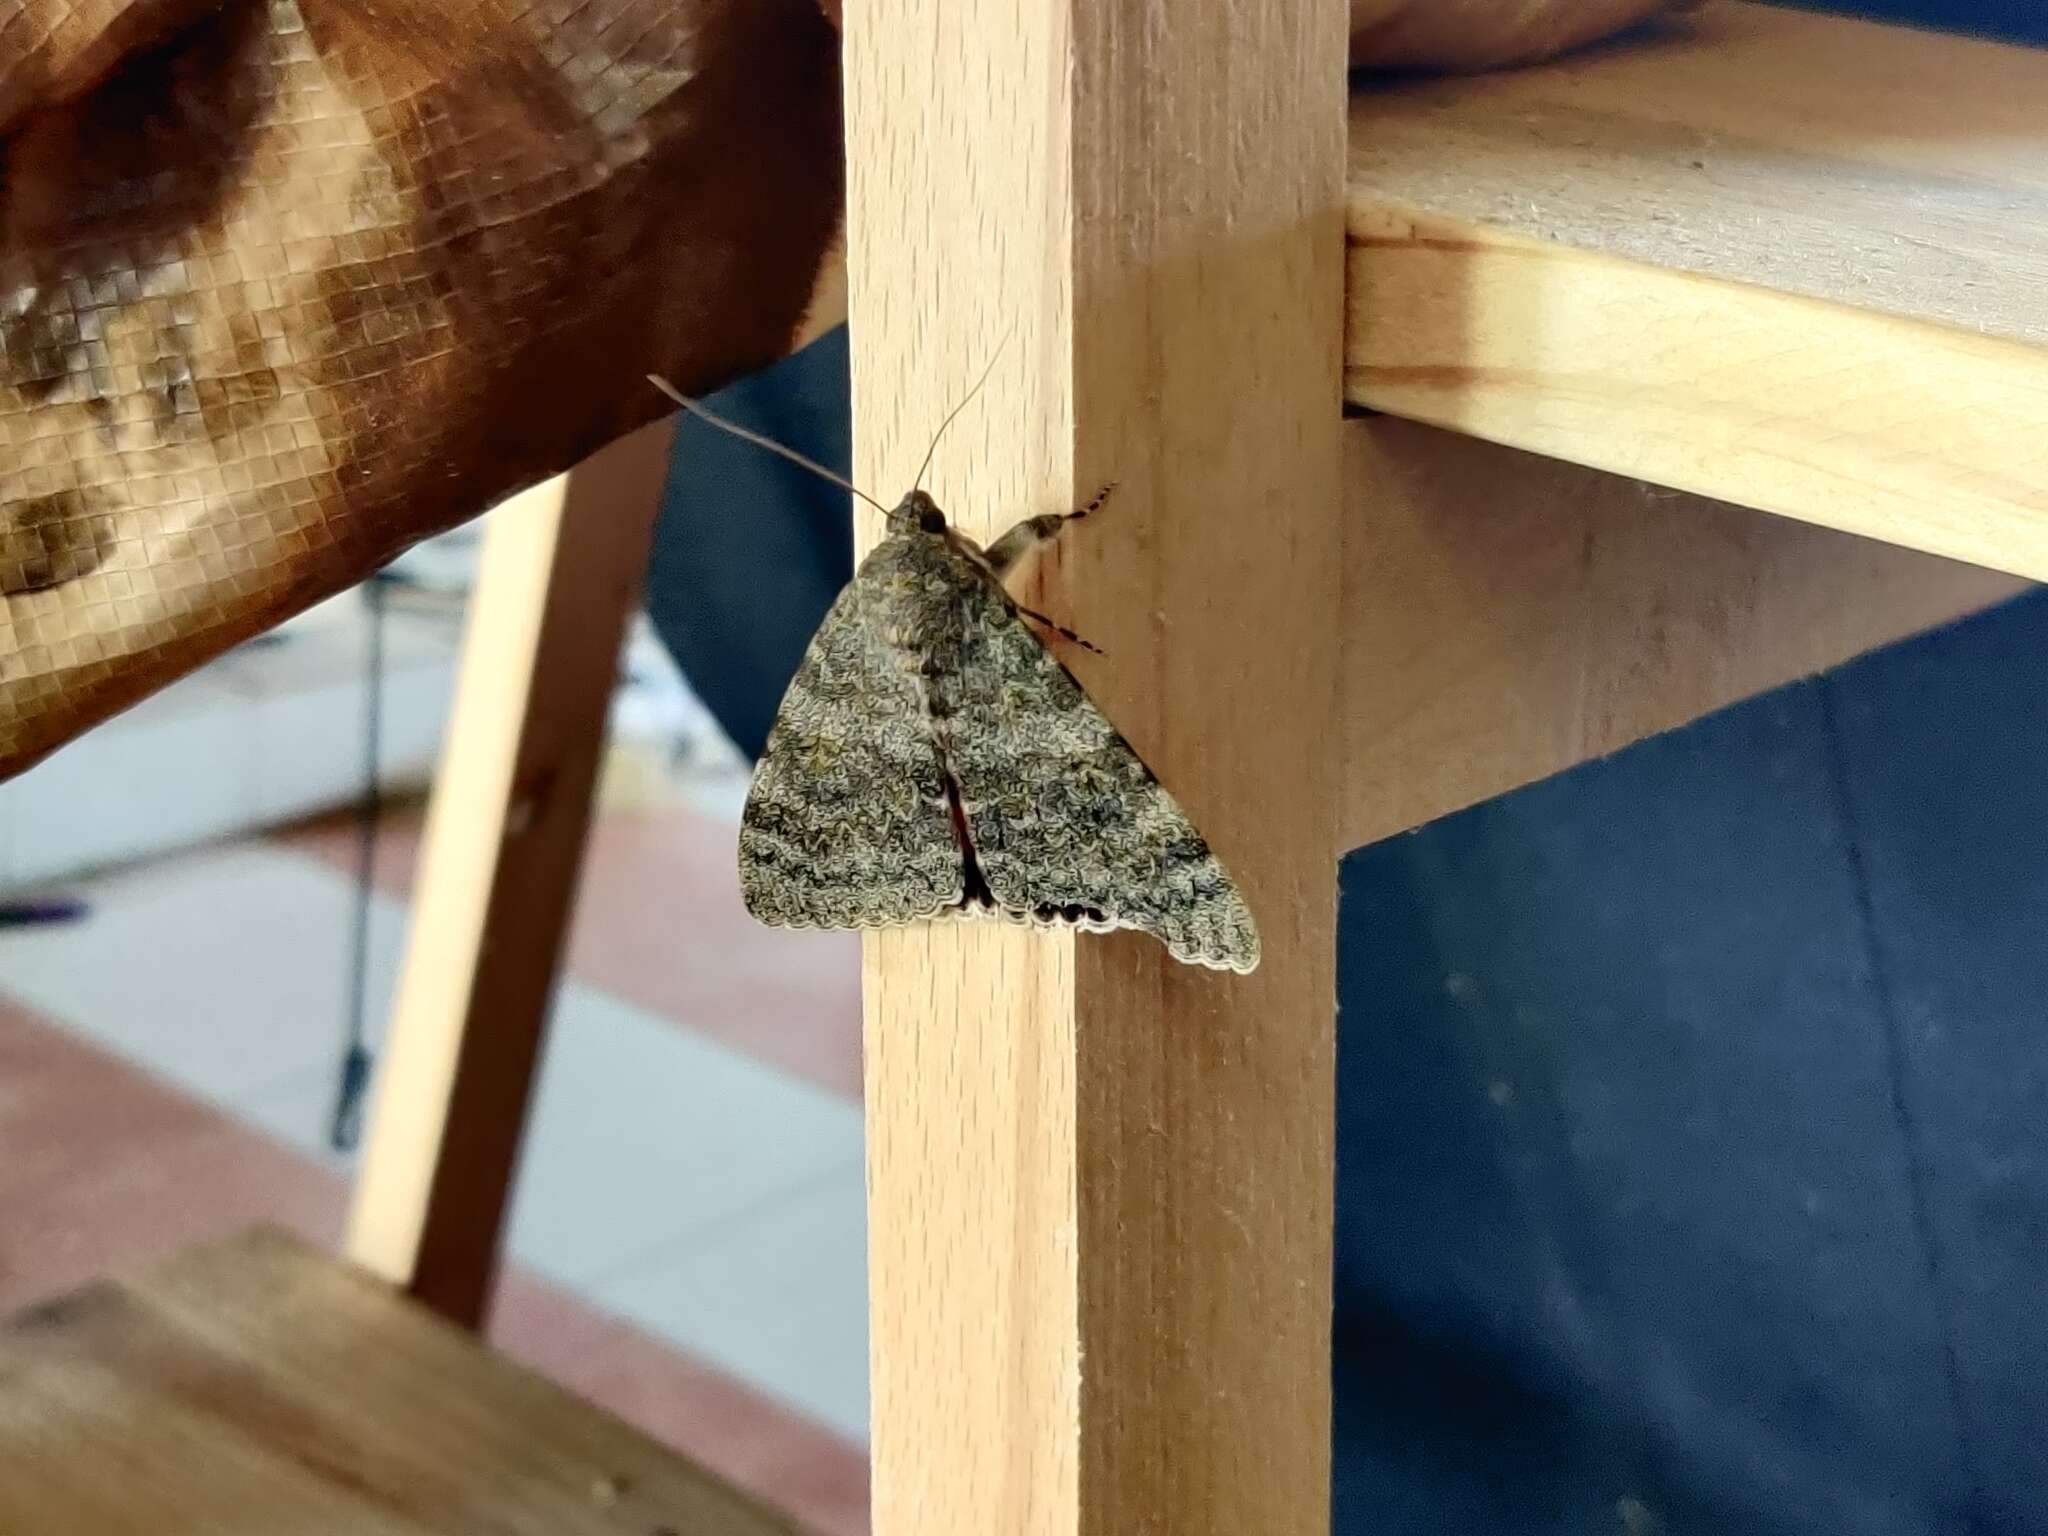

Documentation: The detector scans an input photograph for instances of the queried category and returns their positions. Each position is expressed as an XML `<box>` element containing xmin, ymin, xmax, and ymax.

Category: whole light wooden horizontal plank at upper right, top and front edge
<box><xmin>1346</xmin><ymin>0</ymin><xmax>2048</xmax><ymax>578</ymax></box>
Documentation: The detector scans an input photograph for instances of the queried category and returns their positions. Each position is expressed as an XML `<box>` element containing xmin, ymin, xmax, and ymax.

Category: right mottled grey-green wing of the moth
<box><xmin>946</xmin><ymin>571</ymin><xmax>1260</xmax><ymax>971</ymax></box>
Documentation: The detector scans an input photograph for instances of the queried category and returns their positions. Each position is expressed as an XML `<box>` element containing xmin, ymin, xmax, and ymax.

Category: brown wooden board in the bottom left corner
<box><xmin>0</xmin><ymin>1233</ymin><xmax>795</xmax><ymax>1536</ymax></box>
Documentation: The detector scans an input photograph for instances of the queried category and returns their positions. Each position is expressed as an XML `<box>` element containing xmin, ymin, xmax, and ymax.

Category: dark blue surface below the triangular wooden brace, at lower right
<box><xmin>1337</xmin><ymin>594</ymin><xmax>2048</xmax><ymax>1536</ymax></box>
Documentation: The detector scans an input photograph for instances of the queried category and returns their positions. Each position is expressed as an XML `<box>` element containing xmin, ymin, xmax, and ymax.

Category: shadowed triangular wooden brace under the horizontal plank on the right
<box><xmin>1341</xmin><ymin>418</ymin><xmax>2025</xmax><ymax>848</ymax></box>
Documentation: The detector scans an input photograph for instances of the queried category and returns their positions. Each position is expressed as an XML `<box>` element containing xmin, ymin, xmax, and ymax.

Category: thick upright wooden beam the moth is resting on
<box><xmin>846</xmin><ymin>0</ymin><xmax>1346</xmax><ymax>1536</ymax></box>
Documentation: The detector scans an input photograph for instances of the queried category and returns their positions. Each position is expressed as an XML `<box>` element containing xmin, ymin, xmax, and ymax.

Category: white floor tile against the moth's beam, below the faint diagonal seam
<box><xmin>588</xmin><ymin>1163</ymin><xmax>868</xmax><ymax>1442</ymax></box>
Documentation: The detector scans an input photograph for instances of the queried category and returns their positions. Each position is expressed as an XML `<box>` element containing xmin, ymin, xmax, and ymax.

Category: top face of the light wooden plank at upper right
<box><xmin>1350</xmin><ymin>0</ymin><xmax>2048</xmax><ymax>344</ymax></box>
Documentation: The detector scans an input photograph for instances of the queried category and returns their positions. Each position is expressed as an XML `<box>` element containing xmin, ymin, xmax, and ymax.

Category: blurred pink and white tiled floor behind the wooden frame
<box><xmin>0</xmin><ymin>786</ymin><xmax>866</xmax><ymax>1536</ymax></box>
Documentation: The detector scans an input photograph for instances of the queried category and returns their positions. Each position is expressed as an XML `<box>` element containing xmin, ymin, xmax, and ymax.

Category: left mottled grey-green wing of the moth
<box><xmin>739</xmin><ymin>565</ymin><xmax>965</xmax><ymax>928</ymax></box>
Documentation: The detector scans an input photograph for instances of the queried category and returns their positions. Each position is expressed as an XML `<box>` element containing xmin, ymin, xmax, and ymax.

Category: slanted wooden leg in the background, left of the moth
<box><xmin>348</xmin><ymin>420</ymin><xmax>674</xmax><ymax>1327</ymax></box>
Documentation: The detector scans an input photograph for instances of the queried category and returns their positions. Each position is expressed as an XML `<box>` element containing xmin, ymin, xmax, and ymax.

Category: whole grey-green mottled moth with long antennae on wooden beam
<box><xmin>653</xmin><ymin>379</ymin><xmax>1260</xmax><ymax>973</ymax></box>
